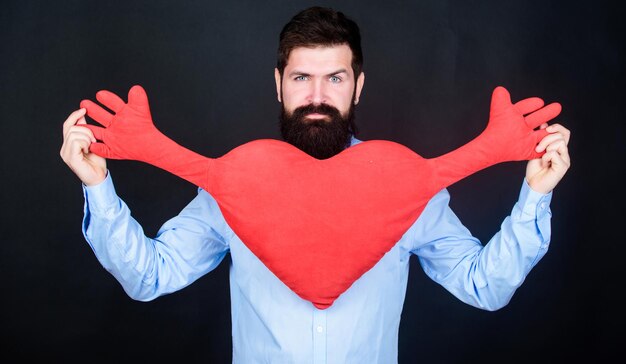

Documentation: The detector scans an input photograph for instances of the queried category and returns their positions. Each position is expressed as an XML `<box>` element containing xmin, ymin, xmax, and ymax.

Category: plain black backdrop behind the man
<box><xmin>0</xmin><ymin>0</ymin><xmax>624</xmax><ymax>363</ymax></box>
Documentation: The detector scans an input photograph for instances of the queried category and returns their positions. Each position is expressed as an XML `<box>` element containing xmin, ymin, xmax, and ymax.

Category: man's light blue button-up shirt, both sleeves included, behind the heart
<box><xmin>83</xmin><ymin>139</ymin><xmax>552</xmax><ymax>364</ymax></box>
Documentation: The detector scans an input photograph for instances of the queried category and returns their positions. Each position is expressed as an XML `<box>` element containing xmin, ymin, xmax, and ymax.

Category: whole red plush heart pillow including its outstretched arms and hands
<box><xmin>81</xmin><ymin>86</ymin><xmax>561</xmax><ymax>309</ymax></box>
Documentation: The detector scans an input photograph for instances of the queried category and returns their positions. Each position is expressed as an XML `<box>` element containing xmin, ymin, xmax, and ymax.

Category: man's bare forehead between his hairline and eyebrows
<box><xmin>285</xmin><ymin>44</ymin><xmax>352</xmax><ymax>73</ymax></box>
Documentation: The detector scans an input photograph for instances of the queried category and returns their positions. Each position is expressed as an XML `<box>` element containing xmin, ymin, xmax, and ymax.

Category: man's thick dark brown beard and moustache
<box><xmin>280</xmin><ymin>102</ymin><xmax>357</xmax><ymax>159</ymax></box>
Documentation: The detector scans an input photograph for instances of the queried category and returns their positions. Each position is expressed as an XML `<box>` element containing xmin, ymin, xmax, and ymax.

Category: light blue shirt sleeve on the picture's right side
<box><xmin>412</xmin><ymin>180</ymin><xmax>552</xmax><ymax>311</ymax></box>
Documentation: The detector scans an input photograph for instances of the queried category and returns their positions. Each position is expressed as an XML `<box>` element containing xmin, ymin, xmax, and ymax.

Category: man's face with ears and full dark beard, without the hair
<box><xmin>275</xmin><ymin>45</ymin><xmax>365</xmax><ymax>159</ymax></box>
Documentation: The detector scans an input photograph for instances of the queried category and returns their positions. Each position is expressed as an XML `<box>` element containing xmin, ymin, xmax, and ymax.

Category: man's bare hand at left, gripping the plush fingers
<box><xmin>60</xmin><ymin>108</ymin><xmax>107</xmax><ymax>186</ymax></box>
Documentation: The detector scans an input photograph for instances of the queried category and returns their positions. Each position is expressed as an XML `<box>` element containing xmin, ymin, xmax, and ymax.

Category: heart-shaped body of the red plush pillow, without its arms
<box><xmin>208</xmin><ymin>140</ymin><xmax>437</xmax><ymax>308</ymax></box>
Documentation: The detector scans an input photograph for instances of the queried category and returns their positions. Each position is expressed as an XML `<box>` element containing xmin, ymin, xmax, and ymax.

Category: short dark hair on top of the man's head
<box><xmin>276</xmin><ymin>6</ymin><xmax>363</xmax><ymax>79</ymax></box>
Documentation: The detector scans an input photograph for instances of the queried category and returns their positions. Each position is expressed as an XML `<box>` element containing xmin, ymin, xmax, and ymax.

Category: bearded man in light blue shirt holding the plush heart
<box><xmin>61</xmin><ymin>7</ymin><xmax>569</xmax><ymax>364</ymax></box>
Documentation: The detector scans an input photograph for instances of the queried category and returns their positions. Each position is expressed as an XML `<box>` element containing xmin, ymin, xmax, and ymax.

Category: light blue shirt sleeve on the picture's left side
<box><xmin>82</xmin><ymin>173</ymin><xmax>229</xmax><ymax>301</ymax></box>
